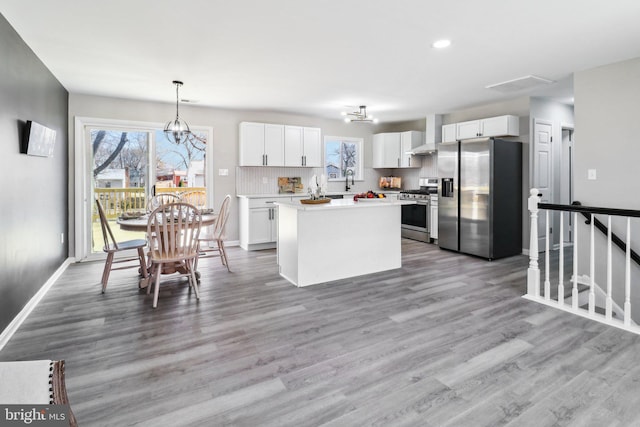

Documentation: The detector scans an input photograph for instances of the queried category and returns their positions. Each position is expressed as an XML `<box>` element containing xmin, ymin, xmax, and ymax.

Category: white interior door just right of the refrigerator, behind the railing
<box><xmin>533</xmin><ymin>119</ymin><xmax>553</xmax><ymax>251</ymax></box>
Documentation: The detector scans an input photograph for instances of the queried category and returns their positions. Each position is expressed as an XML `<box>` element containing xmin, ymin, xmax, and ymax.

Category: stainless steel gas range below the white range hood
<box><xmin>398</xmin><ymin>178</ymin><xmax>438</xmax><ymax>242</ymax></box>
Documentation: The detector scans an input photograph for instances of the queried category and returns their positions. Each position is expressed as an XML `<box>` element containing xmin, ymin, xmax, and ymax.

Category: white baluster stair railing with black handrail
<box><xmin>525</xmin><ymin>188</ymin><xmax>640</xmax><ymax>334</ymax></box>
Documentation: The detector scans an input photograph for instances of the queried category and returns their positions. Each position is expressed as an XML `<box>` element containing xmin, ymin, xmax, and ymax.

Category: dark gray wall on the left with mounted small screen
<box><xmin>0</xmin><ymin>15</ymin><xmax>69</xmax><ymax>331</ymax></box>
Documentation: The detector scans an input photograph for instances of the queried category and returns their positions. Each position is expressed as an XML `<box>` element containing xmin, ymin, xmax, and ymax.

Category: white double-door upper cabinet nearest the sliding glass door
<box><xmin>239</xmin><ymin>122</ymin><xmax>284</xmax><ymax>166</ymax></box>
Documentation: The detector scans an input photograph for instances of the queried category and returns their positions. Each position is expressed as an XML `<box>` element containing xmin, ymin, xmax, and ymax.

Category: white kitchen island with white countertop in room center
<box><xmin>275</xmin><ymin>199</ymin><xmax>415</xmax><ymax>286</ymax></box>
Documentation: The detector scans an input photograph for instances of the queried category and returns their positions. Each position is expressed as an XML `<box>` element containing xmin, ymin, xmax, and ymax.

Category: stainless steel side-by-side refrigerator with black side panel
<box><xmin>438</xmin><ymin>138</ymin><xmax>523</xmax><ymax>260</ymax></box>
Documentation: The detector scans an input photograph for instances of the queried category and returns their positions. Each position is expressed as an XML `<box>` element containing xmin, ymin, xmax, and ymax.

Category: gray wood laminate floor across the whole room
<box><xmin>0</xmin><ymin>240</ymin><xmax>640</xmax><ymax>427</ymax></box>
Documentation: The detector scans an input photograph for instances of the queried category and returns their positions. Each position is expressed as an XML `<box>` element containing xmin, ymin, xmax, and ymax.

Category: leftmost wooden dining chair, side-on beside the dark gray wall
<box><xmin>96</xmin><ymin>199</ymin><xmax>147</xmax><ymax>293</ymax></box>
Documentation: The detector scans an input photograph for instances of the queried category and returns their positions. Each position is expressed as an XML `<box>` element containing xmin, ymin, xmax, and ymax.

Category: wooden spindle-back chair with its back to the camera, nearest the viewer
<box><xmin>147</xmin><ymin>202</ymin><xmax>202</xmax><ymax>308</ymax></box>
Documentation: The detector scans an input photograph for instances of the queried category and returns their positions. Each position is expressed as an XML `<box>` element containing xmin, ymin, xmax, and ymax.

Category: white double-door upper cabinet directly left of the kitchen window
<box><xmin>284</xmin><ymin>126</ymin><xmax>322</xmax><ymax>167</ymax></box>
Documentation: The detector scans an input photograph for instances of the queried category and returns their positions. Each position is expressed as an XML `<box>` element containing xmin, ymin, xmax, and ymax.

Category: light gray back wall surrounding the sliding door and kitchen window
<box><xmin>69</xmin><ymin>94</ymin><xmax>388</xmax><ymax>254</ymax></box>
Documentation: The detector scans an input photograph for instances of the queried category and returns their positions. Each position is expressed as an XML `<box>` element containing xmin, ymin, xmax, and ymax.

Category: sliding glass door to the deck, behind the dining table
<box><xmin>74</xmin><ymin>118</ymin><xmax>213</xmax><ymax>260</ymax></box>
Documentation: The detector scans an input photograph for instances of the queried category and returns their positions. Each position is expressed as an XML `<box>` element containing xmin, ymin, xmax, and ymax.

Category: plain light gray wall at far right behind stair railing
<box><xmin>574</xmin><ymin>58</ymin><xmax>640</xmax><ymax>321</ymax></box>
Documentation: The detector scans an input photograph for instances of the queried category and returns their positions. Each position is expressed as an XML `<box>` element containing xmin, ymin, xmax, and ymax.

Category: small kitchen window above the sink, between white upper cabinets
<box><xmin>324</xmin><ymin>136</ymin><xmax>364</xmax><ymax>181</ymax></box>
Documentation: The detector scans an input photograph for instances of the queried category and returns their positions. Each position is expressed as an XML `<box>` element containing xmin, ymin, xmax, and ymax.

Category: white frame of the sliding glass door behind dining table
<box><xmin>73</xmin><ymin>116</ymin><xmax>214</xmax><ymax>262</ymax></box>
